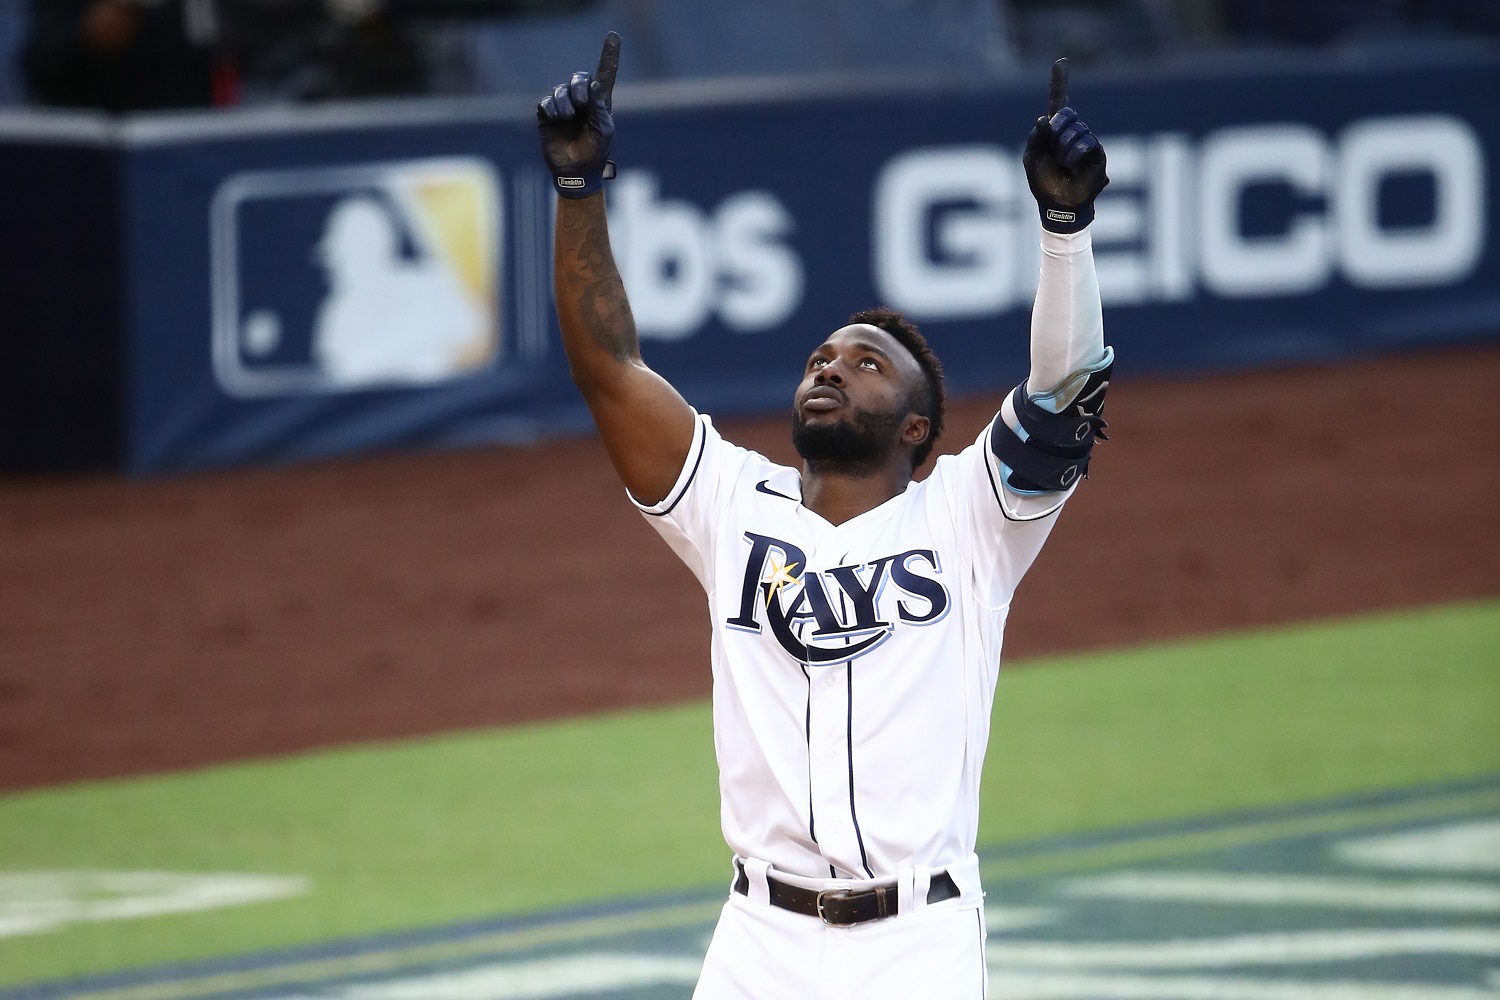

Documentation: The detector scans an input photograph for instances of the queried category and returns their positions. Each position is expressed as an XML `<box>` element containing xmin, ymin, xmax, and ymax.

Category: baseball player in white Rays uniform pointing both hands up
<box><xmin>537</xmin><ymin>33</ymin><xmax>1115</xmax><ymax>1000</ymax></box>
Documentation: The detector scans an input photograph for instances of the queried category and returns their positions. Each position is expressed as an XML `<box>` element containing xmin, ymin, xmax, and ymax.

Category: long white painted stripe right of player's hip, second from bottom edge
<box><xmin>984</xmin><ymin>927</ymin><xmax>1500</xmax><ymax>969</ymax></box>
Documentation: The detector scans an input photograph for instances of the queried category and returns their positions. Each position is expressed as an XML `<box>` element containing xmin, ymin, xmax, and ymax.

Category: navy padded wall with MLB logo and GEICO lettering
<box><xmin>0</xmin><ymin>46</ymin><xmax>1500</xmax><ymax>472</ymax></box>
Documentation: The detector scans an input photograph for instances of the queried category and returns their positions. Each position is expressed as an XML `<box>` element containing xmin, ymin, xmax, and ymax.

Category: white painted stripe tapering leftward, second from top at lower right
<box><xmin>1064</xmin><ymin>871</ymin><xmax>1500</xmax><ymax>913</ymax></box>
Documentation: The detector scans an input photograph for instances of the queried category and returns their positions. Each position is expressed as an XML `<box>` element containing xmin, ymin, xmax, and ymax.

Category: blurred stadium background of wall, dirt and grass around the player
<box><xmin>0</xmin><ymin>0</ymin><xmax>1500</xmax><ymax>1000</ymax></box>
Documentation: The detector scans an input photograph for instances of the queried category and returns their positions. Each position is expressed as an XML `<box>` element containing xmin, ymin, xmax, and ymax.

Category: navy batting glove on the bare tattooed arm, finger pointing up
<box><xmin>537</xmin><ymin>31</ymin><xmax>620</xmax><ymax>198</ymax></box>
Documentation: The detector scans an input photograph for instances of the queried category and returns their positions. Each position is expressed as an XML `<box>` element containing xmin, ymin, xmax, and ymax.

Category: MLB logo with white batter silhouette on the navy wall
<box><xmin>210</xmin><ymin>157</ymin><xmax>501</xmax><ymax>399</ymax></box>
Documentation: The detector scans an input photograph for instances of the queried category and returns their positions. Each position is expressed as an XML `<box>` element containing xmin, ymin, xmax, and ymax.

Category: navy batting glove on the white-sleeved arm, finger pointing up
<box><xmin>1022</xmin><ymin>58</ymin><xmax>1110</xmax><ymax>232</ymax></box>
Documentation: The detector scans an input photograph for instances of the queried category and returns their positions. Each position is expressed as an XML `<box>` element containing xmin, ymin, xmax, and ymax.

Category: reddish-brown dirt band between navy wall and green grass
<box><xmin>0</xmin><ymin>345</ymin><xmax>1500</xmax><ymax>789</ymax></box>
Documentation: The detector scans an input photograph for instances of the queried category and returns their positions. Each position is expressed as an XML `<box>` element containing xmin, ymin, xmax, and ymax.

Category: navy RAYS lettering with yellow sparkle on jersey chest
<box><xmin>725</xmin><ymin>531</ymin><xmax>950</xmax><ymax>664</ymax></box>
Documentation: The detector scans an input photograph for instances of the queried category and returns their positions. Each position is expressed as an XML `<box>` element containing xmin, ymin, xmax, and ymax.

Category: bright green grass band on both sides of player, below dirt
<box><xmin>0</xmin><ymin>603</ymin><xmax>1500</xmax><ymax>984</ymax></box>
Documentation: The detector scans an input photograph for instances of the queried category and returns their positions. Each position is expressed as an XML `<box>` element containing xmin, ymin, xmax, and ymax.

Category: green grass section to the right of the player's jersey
<box><xmin>980</xmin><ymin>601</ymin><xmax>1500</xmax><ymax>841</ymax></box>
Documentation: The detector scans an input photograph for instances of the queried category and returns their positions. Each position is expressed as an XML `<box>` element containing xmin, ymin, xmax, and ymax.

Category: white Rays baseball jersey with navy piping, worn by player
<box><xmin>641</xmin><ymin>417</ymin><xmax>1067</xmax><ymax>879</ymax></box>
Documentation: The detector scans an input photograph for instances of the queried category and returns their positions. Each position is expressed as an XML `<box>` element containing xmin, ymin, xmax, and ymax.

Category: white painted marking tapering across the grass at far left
<box><xmin>0</xmin><ymin>870</ymin><xmax>312</xmax><ymax>937</ymax></box>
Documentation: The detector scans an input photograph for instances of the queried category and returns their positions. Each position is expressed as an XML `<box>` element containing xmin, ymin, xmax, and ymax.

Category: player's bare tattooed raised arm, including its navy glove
<box><xmin>537</xmin><ymin>31</ymin><xmax>696</xmax><ymax>505</ymax></box>
